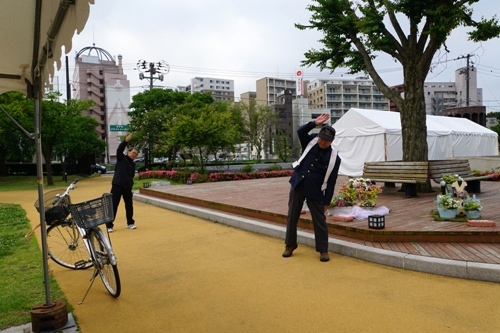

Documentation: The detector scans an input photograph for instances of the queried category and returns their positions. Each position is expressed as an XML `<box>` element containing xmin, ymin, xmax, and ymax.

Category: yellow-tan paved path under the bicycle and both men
<box><xmin>0</xmin><ymin>177</ymin><xmax>500</xmax><ymax>333</ymax></box>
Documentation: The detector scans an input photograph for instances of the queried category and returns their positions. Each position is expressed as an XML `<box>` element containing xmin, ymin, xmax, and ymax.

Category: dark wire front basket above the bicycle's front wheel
<box><xmin>69</xmin><ymin>193</ymin><xmax>114</xmax><ymax>229</ymax></box>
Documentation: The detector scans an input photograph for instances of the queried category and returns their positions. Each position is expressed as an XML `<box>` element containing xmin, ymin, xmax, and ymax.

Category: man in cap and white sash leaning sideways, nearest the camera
<box><xmin>283</xmin><ymin>113</ymin><xmax>341</xmax><ymax>262</ymax></box>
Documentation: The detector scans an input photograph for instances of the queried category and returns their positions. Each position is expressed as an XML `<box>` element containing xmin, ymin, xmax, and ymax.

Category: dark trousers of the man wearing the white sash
<box><xmin>285</xmin><ymin>183</ymin><xmax>328</xmax><ymax>252</ymax></box>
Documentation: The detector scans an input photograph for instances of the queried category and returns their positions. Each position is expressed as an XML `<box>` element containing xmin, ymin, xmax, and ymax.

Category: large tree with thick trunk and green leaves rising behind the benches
<box><xmin>296</xmin><ymin>0</ymin><xmax>500</xmax><ymax>161</ymax></box>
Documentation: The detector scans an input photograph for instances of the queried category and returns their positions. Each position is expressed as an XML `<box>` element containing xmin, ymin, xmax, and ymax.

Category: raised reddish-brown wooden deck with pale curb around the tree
<box><xmin>135</xmin><ymin>178</ymin><xmax>500</xmax><ymax>282</ymax></box>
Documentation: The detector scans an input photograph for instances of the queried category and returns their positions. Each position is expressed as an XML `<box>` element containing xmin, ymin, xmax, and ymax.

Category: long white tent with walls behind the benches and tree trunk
<box><xmin>332</xmin><ymin>109</ymin><xmax>498</xmax><ymax>176</ymax></box>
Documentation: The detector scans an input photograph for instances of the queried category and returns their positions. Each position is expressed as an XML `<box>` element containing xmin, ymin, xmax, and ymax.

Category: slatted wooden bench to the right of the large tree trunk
<box><xmin>429</xmin><ymin>160</ymin><xmax>493</xmax><ymax>193</ymax></box>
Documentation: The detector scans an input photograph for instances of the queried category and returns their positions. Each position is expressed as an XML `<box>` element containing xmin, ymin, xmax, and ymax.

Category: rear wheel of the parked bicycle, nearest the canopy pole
<box><xmin>47</xmin><ymin>219</ymin><xmax>93</xmax><ymax>269</ymax></box>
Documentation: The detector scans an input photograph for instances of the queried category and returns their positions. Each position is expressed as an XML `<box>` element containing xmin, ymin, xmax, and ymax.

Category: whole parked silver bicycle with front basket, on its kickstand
<box><xmin>32</xmin><ymin>179</ymin><xmax>121</xmax><ymax>304</ymax></box>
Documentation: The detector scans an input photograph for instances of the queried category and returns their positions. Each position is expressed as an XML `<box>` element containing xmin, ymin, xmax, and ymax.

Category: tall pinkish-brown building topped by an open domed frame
<box><xmin>73</xmin><ymin>45</ymin><xmax>130</xmax><ymax>163</ymax></box>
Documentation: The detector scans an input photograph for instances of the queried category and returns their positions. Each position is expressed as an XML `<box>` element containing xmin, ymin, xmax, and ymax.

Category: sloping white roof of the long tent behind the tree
<box><xmin>332</xmin><ymin>108</ymin><xmax>497</xmax><ymax>137</ymax></box>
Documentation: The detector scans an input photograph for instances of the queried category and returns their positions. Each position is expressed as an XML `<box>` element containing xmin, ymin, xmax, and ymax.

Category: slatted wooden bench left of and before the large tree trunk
<box><xmin>363</xmin><ymin>161</ymin><xmax>429</xmax><ymax>198</ymax></box>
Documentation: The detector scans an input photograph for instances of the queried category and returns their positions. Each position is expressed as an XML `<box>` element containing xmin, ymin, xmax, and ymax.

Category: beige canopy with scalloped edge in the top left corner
<box><xmin>0</xmin><ymin>0</ymin><xmax>94</xmax><ymax>94</ymax></box>
